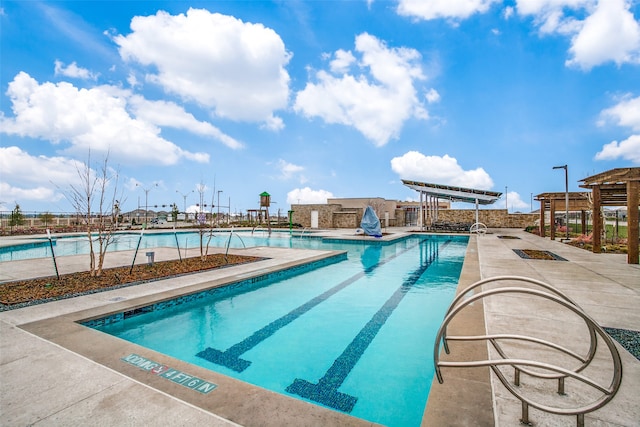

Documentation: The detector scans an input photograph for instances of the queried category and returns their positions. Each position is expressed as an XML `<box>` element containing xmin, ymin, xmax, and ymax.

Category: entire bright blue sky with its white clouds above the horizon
<box><xmin>0</xmin><ymin>0</ymin><xmax>640</xmax><ymax>213</ymax></box>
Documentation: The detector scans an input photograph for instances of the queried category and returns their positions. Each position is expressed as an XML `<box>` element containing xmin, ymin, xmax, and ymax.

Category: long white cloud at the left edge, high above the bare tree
<box><xmin>0</xmin><ymin>72</ymin><xmax>218</xmax><ymax>165</ymax></box>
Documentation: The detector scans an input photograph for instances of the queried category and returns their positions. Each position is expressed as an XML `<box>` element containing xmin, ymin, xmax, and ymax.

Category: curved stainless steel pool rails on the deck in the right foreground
<box><xmin>433</xmin><ymin>276</ymin><xmax>622</xmax><ymax>427</ymax></box>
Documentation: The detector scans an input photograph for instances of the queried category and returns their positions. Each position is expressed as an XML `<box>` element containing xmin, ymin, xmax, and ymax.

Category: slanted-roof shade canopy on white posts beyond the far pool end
<box><xmin>402</xmin><ymin>179</ymin><xmax>502</xmax><ymax>226</ymax></box>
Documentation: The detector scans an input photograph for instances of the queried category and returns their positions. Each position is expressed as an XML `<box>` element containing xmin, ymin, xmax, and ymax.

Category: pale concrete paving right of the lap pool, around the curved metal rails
<box><xmin>478</xmin><ymin>229</ymin><xmax>640</xmax><ymax>427</ymax></box>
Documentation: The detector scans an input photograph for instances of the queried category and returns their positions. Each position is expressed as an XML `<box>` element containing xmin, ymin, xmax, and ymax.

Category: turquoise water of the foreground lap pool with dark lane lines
<box><xmin>87</xmin><ymin>236</ymin><xmax>468</xmax><ymax>426</ymax></box>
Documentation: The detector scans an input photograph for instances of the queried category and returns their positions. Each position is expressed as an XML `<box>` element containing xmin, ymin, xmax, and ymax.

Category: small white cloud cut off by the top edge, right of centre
<box><xmin>397</xmin><ymin>0</ymin><xmax>500</xmax><ymax>20</ymax></box>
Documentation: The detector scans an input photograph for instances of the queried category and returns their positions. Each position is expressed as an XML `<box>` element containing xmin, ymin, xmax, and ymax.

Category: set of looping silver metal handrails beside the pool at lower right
<box><xmin>434</xmin><ymin>276</ymin><xmax>622</xmax><ymax>425</ymax></box>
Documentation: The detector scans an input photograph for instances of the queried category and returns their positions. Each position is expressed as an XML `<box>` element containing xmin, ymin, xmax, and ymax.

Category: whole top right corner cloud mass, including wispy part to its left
<box><xmin>517</xmin><ymin>0</ymin><xmax>640</xmax><ymax>70</ymax></box>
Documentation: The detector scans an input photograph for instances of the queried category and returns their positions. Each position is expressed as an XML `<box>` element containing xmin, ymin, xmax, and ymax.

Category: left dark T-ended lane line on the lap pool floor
<box><xmin>196</xmin><ymin>245</ymin><xmax>416</xmax><ymax>372</ymax></box>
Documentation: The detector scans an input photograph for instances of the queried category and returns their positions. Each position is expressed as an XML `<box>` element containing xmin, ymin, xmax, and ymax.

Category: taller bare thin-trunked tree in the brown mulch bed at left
<box><xmin>65</xmin><ymin>152</ymin><xmax>122</xmax><ymax>277</ymax></box>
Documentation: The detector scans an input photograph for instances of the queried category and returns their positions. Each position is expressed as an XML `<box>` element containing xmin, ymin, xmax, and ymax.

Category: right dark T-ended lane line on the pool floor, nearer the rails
<box><xmin>285</xmin><ymin>241</ymin><xmax>449</xmax><ymax>413</ymax></box>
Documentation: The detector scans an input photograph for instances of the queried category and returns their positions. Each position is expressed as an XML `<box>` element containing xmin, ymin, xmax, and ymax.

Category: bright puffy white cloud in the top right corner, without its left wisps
<box><xmin>567</xmin><ymin>0</ymin><xmax>640</xmax><ymax>70</ymax></box>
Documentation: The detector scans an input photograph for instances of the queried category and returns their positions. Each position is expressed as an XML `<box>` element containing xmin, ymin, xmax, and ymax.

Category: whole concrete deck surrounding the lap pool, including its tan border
<box><xmin>0</xmin><ymin>229</ymin><xmax>640</xmax><ymax>426</ymax></box>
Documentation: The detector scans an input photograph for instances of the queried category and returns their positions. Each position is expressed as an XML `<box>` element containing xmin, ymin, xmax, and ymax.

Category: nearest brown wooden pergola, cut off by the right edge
<box><xmin>580</xmin><ymin>168</ymin><xmax>640</xmax><ymax>264</ymax></box>
